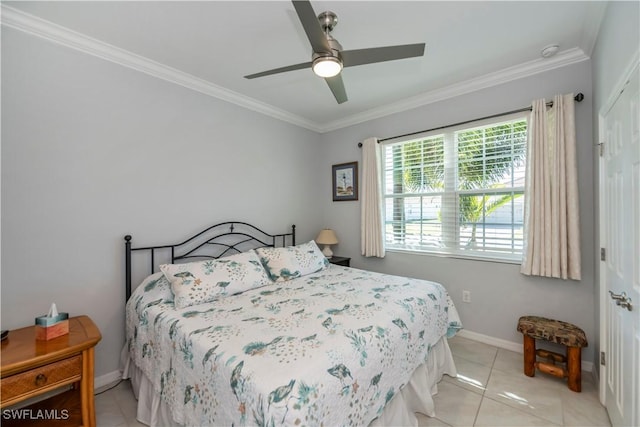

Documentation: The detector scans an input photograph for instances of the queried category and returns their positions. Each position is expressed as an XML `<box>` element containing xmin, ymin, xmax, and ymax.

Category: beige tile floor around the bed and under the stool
<box><xmin>96</xmin><ymin>337</ymin><xmax>611</xmax><ymax>427</ymax></box>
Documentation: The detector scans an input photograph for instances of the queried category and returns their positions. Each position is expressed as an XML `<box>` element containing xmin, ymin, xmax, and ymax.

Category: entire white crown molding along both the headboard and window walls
<box><xmin>0</xmin><ymin>4</ymin><xmax>592</xmax><ymax>133</ymax></box>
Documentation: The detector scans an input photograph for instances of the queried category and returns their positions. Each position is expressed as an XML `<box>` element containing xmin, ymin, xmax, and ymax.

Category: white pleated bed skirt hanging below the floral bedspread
<box><xmin>122</xmin><ymin>337</ymin><xmax>457</xmax><ymax>427</ymax></box>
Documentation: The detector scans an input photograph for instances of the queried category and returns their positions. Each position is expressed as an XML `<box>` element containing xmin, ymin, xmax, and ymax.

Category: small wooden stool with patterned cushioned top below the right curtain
<box><xmin>518</xmin><ymin>316</ymin><xmax>588</xmax><ymax>393</ymax></box>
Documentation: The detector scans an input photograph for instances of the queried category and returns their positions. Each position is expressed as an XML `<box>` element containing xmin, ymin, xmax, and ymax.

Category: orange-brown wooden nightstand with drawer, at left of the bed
<box><xmin>0</xmin><ymin>316</ymin><xmax>102</xmax><ymax>427</ymax></box>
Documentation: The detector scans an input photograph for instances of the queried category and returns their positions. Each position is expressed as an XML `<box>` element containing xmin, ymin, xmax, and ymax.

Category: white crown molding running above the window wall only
<box><xmin>322</xmin><ymin>48</ymin><xmax>589</xmax><ymax>132</ymax></box>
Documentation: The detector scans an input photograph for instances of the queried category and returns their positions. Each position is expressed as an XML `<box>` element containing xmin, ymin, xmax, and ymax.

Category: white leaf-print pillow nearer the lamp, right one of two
<box><xmin>256</xmin><ymin>240</ymin><xmax>329</xmax><ymax>282</ymax></box>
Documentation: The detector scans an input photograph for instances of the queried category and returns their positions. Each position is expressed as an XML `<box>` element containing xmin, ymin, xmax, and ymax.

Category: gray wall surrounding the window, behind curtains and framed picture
<box><xmin>322</xmin><ymin>61</ymin><xmax>597</xmax><ymax>361</ymax></box>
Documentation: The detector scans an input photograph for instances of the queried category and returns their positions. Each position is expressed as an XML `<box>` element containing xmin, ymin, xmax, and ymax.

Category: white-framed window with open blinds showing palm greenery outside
<box><xmin>383</xmin><ymin>115</ymin><xmax>527</xmax><ymax>261</ymax></box>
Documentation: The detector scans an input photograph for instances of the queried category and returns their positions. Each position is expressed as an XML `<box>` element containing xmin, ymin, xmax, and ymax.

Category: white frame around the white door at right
<box><xmin>595</xmin><ymin>51</ymin><xmax>640</xmax><ymax>406</ymax></box>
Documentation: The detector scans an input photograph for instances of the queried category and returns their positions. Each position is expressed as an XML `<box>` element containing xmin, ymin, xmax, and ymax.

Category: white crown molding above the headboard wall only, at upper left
<box><xmin>0</xmin><ymin>4</ymin><xmax>321</xmax><ymax>132</ymax></box>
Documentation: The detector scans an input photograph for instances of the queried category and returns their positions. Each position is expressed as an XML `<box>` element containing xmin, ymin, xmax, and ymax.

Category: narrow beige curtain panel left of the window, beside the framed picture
<box><xmin>360</xmin><ymin>138</ymin><xmax>385</xmax><ymax>258</ymax></box>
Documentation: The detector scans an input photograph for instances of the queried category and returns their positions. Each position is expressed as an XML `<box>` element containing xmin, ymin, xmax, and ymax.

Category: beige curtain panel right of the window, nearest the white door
<box><xmin>520</xmin><ymin>94</ymin><xmax>580</xmax><ymax>280</ymax></box>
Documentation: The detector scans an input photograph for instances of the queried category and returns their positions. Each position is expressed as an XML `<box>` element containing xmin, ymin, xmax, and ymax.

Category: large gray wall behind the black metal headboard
<box><xmin>1</xmin><ymin>26</ymin><xmax>324</xmax><ymax>376</ymax></box>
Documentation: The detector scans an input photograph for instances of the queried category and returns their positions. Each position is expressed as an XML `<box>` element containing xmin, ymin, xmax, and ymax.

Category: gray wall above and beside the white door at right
<box><xmin>591</xmin><ymin>1</ymin><xmax>640</xmax><ymax>374</ymax></box>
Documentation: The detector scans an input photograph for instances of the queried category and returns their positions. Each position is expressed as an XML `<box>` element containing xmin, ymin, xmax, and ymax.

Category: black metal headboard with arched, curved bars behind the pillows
<box><xmin>124</xmin><ymin>221</ymin><xmax>296</xmax><ymax>301</ymax></box>
